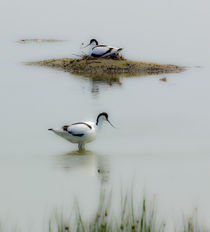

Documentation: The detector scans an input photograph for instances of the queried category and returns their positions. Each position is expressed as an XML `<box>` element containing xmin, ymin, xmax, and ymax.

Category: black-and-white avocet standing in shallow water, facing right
<box><xmin>48</xmin><ymin>112</ymin><xmax>114</xmax><ymax>151</ymax></box>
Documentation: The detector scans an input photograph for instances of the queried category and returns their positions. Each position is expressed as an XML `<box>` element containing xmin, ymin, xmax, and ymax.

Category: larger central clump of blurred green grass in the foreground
<box><xmin>49</xmin><ymin>190</ymin><xmax>165</xmax><ymax>232</ymax></box>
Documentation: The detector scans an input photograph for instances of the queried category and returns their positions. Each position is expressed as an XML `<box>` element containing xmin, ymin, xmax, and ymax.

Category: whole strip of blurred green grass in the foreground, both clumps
<box><xmin>48</xmin><ymin>188</ymin><xmax>207</xmax><ymax>232</ymax></box>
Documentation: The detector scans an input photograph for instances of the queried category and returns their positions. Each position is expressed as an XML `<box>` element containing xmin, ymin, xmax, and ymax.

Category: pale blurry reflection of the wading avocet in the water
<box><xmin>55</xmin><ymin>151</ymin><xmax>109</xmax><ymax>184</ymax></box>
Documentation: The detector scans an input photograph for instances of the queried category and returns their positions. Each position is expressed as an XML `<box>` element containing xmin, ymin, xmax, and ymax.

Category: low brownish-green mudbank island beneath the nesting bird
<box><xmin>27</xmin><ymin>56</ymin><xmax>184</xmax><ymax>78</ymax></box>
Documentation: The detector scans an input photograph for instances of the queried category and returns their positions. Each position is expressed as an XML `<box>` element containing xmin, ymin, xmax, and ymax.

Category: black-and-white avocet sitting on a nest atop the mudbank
<box><xmin>86</xmin><ymin>39</ymin><xmax>123</xmax><ymax>57</ymax></box>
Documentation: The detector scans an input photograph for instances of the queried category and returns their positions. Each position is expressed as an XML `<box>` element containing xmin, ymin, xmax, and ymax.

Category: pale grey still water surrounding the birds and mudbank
<box><xmin>0</xmin><ymin>0</ymin><xmax>210</xmax><ymax>231</ymax></box>
